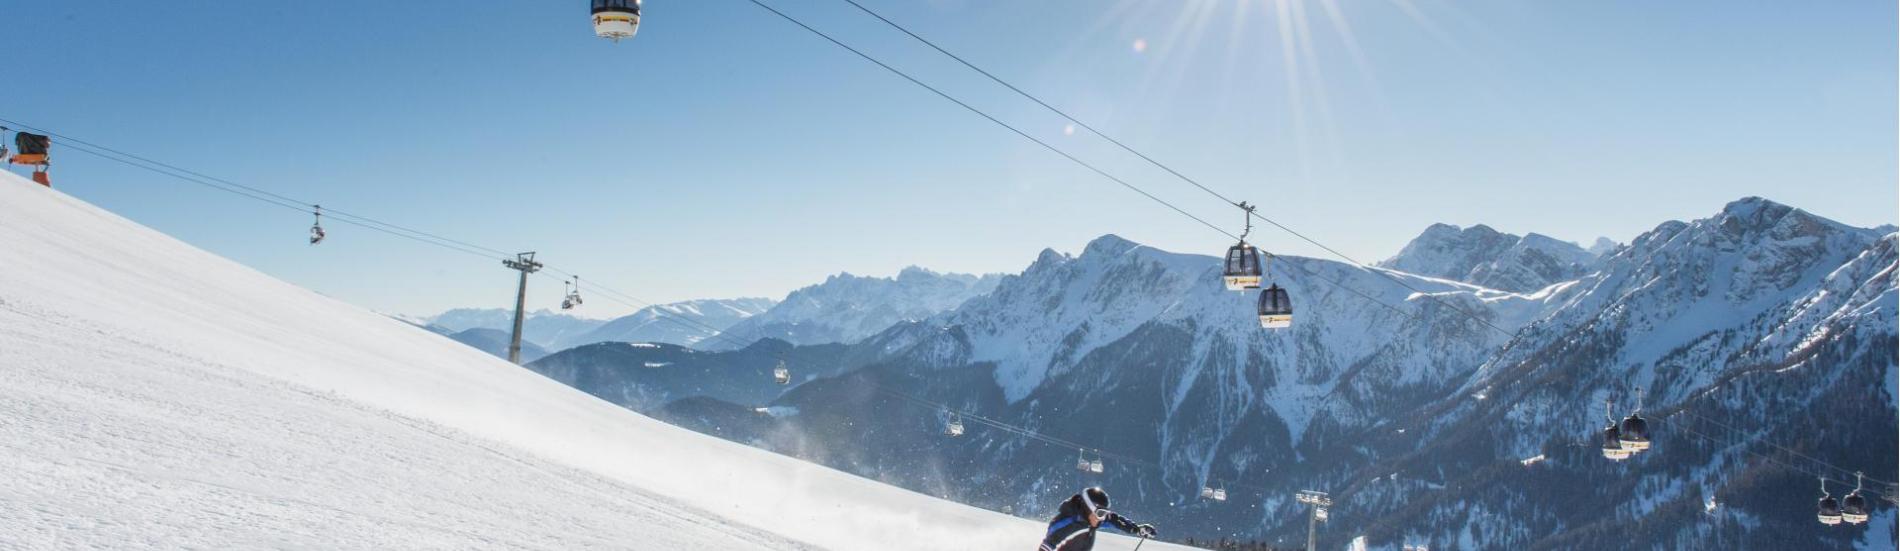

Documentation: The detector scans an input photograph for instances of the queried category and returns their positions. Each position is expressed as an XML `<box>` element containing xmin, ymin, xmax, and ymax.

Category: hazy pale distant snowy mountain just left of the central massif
<box><xmin>701</xmin><ymin>266</ymin><xmax>1001</xmax><ymax>350</ymax></box>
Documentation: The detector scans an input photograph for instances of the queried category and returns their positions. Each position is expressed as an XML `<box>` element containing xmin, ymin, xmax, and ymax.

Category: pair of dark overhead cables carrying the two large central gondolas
<box><xmin>801</xmin><ymin>0</ymin><xmax>1514</xmax><ymax>338</ymax></box>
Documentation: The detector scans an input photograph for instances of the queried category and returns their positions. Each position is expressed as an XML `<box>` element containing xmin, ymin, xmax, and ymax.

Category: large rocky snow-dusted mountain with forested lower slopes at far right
<box><xmin>1375</xmin><ymin>198</ymin><xmax>1900</xmax><ymax>549</ymax></box>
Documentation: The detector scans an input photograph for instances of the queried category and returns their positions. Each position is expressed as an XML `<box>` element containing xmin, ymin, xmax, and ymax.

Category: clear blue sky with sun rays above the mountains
<box><xmin>11</xmin><ymin>0</ymin><xmax>1900</xmax><ymax>315</ymax></box>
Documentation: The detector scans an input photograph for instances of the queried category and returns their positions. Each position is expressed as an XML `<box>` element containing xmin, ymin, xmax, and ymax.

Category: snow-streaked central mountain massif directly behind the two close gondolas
<box><xmin>777</xmin><ymin>236</ymin><xmax>1547</xmax><ymax>530</ymax></box>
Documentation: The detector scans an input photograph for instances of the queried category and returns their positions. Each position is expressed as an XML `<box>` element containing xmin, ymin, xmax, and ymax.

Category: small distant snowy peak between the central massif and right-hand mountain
<box><xmin>1379</xmin><ymin>224</ymin><xmax>1613</xmax><ymax>293</ymax></box>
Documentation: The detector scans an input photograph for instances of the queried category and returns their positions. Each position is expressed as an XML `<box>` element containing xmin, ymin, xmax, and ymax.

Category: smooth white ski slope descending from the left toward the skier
<box><xmin>0</xmin><ymin>173</ymin><xmax>1182</xmax><ymax>549</ymax></box>
